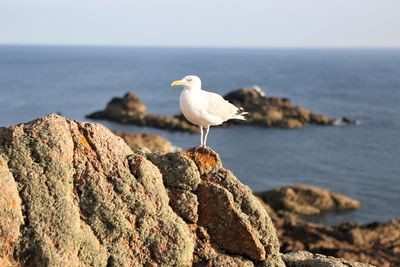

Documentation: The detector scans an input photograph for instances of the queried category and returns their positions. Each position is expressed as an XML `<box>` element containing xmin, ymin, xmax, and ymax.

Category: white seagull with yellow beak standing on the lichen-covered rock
<box><xmin>171</xmin><ymin>75</ymin><xmax>247</xmax><ymax>148</ymax></box>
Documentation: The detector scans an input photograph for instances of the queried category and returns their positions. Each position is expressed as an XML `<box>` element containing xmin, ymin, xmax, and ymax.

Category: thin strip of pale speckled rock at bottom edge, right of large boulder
<box><xmin>282</xmin><ymin>251</ymin><xmax>373</xmax><ymax>267</ymax></box>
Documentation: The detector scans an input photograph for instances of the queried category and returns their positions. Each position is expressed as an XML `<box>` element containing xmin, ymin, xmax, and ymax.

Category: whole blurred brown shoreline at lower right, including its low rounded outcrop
<box><xmin>257</xmin><ymin>185</ymin><xmax>400</xmax><ymax>267</ymax></box>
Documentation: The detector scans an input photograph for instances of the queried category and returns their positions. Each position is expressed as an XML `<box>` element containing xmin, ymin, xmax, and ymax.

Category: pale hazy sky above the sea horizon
<box><xmin>0</xmin><ymin>0</ymin><xmax>400</xmax><ymax>48</ymax></box>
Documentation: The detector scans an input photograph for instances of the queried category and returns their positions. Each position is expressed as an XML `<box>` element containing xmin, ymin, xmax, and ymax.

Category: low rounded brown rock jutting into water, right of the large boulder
<box><xmin>258</xmin><ymin>185</ymin><xmax>360</xmax><ymax>215</ymax></box>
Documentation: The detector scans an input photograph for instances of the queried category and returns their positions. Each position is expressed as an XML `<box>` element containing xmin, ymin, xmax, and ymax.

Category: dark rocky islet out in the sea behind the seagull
<box><xmin>87</xmin><ymin>86</ymin><xmax>355</xmax><ymax>133</ymax></box>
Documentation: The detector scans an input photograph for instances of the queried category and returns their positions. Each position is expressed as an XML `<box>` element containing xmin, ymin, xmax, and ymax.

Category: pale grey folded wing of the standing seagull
<box><xmin>205</xmin><ymin>92</ymin><xmax>239</xmax><ymax>121</ymax></box>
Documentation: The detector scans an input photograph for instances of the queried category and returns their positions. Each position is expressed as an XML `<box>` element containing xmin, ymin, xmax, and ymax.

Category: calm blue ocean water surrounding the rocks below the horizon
<box><xmin>0</xmin><ymin>46</ymin><xmax>400</xmax><ymax>224</ymax></box>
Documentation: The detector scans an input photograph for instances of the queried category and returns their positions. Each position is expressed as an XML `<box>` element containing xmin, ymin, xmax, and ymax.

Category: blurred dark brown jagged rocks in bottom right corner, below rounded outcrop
<box><xmin>260</xmin><ymin>194</ymin><xmax>400</xmax><ymax>267</ymax></box>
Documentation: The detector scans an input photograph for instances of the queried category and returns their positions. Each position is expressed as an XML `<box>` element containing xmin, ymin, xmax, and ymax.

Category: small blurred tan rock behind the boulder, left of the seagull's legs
<box><xmin>114</xmin><ymin>131</ymin><xmax>172</xmax><ymax>152</ymax></box>
